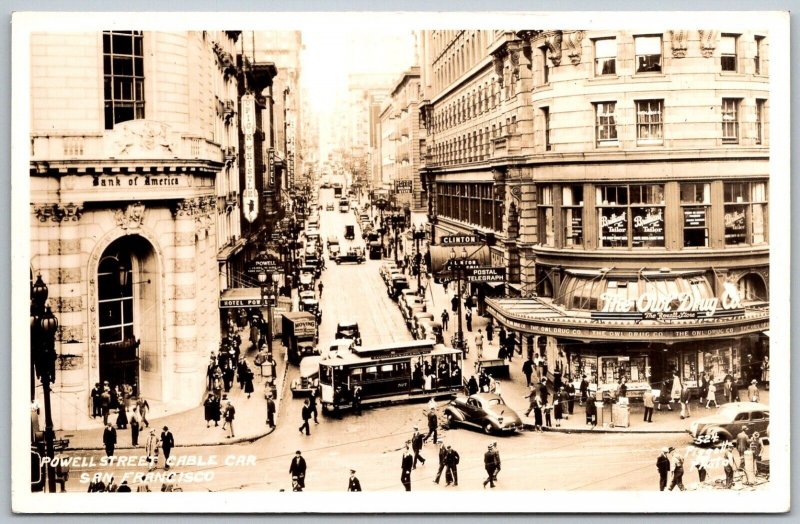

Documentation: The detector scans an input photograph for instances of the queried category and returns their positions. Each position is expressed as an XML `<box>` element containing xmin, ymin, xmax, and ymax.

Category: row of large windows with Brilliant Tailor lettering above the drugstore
<box><xmin>537</xmin><ymin>181</ymin><xmax>768</xmax><ymax>249</ymax></box>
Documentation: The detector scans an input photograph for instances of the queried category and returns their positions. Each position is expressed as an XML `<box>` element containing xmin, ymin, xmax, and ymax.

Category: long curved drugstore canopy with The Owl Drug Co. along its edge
<box><xmin>486</xmin><ymin>297</ymin><xmax>769</xmax><ymax>343</ymax></box>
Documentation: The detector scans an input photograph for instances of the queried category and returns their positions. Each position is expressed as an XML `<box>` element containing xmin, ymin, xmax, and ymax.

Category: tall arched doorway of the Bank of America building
<box><xmin>97</xmin><ymin>235</ymin><xmax>160</xmax><ymax>398</ymax></box>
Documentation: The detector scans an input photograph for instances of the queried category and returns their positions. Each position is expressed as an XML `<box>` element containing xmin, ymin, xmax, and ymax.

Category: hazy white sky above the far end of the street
<box><xmin>301</xmin><ymin>30</ymin><xmax>414</xmax><ymax>113</ymax></box>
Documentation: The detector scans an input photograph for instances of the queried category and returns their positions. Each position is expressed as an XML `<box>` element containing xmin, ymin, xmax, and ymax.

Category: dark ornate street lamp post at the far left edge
<box><xmin>31</xmin><ymin>275</ymin><xmax>58</xmax><ymax>493</ymax></box>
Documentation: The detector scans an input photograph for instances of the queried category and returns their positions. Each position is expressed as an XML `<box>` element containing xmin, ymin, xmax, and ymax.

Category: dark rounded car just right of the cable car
<box><xmin>444</xmin><ymin>393</ymin><xmax>522</xmax><ymax>434</ymax></box>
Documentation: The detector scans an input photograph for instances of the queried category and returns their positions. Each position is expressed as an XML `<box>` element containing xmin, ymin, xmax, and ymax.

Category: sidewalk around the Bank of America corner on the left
<box><xmin>56</xmin><ymin>327</ymin><xmax>287</xmax><ymax>450</ymax></box>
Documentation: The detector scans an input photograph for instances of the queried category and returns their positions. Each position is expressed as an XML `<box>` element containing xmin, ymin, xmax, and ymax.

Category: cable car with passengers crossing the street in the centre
<box><xmin>319</xmin><ymin>340</ymin><xmax>463</xmax><ymax>413</ymax></box>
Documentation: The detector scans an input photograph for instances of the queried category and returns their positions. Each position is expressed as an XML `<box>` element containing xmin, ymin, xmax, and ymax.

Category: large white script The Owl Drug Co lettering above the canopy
<box><xmin>600</xmin><ymin>286</ymin><xmax>742</xmax><ymax>317</ymax></box>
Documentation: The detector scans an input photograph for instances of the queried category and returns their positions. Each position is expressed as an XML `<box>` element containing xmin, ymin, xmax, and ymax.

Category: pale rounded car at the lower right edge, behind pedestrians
<box><xmin>687</xmin><ymin>402</ymin><xmax>769</xmax><ymax>446</ymax></box>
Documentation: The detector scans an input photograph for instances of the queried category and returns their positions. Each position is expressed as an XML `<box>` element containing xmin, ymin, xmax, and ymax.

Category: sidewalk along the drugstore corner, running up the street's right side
<box><xmin>403</xmin><ymin>214</ymin><xmax>769</xmax><ymax>434</ymax></box>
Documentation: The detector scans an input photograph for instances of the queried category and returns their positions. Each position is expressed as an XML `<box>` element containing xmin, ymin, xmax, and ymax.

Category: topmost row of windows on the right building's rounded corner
<box><xmin>539</xmin><ymin>33</ymin><xmax>766</xmax><ymax>84</ymax></box>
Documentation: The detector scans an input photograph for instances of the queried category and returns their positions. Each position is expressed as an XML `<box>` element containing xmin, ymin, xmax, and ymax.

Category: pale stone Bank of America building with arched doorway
<box><xmin>30</xmin><ymin>31</ymin><xmax>241</xmax><ymax>429</ymax></box>
